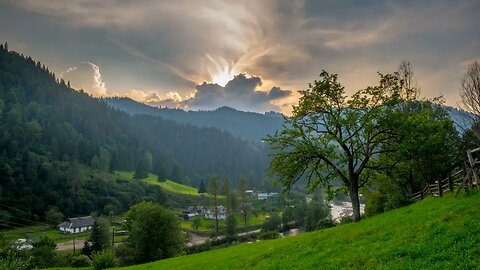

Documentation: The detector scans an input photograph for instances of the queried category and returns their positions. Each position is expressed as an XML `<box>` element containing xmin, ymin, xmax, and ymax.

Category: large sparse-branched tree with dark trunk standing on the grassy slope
<box><xmin>267</xmin><ymin>71</ymin><xmax>402</xmax><ymax>221</ymax></box>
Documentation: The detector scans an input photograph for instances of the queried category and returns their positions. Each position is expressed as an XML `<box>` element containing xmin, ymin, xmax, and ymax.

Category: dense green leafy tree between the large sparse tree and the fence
<box><xmin>380</xmin><ymin>101</ymin><xmax>465</xmax><ymax>195</ymax></box>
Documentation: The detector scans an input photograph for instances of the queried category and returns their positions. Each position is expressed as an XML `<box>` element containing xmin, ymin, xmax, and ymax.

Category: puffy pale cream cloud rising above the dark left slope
<box><xmin>61</xmin><ymin>62</ymin><xmax>107</xmax><ymax>97</ymax></box>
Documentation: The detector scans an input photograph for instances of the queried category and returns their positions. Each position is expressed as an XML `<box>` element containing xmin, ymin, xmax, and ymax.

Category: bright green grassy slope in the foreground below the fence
<box><xmin>82</xmin><ymin>192</ymin><xmax>480</xmax><ymax>270</ymax></box>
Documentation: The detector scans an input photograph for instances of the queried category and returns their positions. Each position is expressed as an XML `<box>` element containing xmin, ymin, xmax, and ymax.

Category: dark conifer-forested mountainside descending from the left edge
<box><xmin>0</xmin><ymin>46</ymin><xmax>268</xmax><ymax>221</ymax></box>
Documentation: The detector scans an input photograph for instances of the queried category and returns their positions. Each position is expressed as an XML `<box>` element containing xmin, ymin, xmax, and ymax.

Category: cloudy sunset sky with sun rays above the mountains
<box><xmin>0</xmin><ymin>0</ymin><xmax>480</xmax><ymax>114</ymax></box>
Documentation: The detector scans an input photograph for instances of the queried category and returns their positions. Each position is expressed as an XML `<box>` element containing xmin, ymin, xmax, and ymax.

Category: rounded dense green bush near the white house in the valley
<box><xmin>125</xmin><ymin>202</ymin><xmax>184</xmax><ymax>263</ymax></box>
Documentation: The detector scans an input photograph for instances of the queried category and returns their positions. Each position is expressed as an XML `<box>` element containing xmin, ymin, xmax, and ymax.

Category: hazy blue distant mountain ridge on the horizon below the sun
<box><xmin>105</xmin><ymin>98</ymin><xmax>283</xmax><ymax>141</ymax></box>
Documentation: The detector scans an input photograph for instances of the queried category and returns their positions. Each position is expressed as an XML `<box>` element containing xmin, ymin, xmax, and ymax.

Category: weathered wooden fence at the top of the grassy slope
<box><xmin>410</xmin><ymin>148</ymin><xmax>480</xmax><ymax>200</ymax></box>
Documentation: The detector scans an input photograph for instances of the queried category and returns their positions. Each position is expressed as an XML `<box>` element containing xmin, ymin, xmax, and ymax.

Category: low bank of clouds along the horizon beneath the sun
<box><xmin>61</xmin><ymin>62</ymin><xmax>292</xmax><ymax>112</ymax></box>
